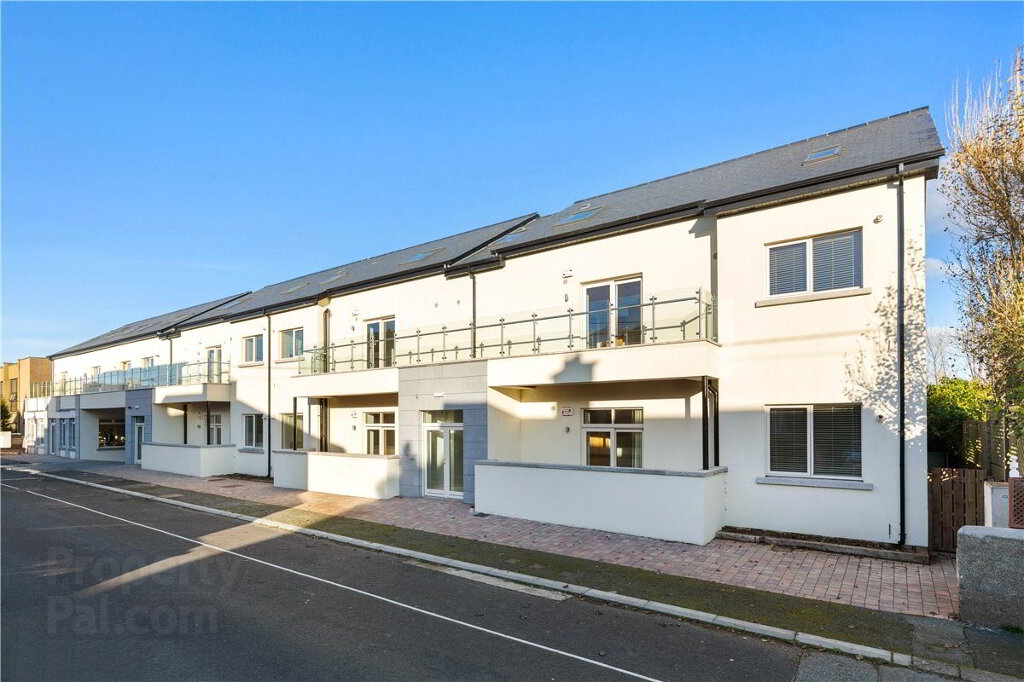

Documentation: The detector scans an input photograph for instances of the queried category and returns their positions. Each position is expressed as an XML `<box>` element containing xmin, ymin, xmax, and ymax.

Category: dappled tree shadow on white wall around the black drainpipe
<box><xmin>845</xmin><ymin>241</ymin><xmax>927</xmax><ymax>438</ymax></box>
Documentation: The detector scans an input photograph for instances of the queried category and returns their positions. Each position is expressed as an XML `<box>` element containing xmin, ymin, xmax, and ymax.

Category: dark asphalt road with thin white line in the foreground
<box><xmin>0</xmin><ymin>471</ymin><xmax>802</xmax><ymax>680</ymax></box>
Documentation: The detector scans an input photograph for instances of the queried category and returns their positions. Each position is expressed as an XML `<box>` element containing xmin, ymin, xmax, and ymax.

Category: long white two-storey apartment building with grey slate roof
<box><xmin>27</xmin><ymin>109</ymin><xmax>943</xmax><ymax>546</ymax></box>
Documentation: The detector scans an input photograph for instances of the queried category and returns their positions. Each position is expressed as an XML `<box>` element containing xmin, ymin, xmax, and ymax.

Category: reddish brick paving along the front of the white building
<box><xmin>6</xmin><ymin>456</ymin><xmax>958</xmax><ymax>617</ymax></box>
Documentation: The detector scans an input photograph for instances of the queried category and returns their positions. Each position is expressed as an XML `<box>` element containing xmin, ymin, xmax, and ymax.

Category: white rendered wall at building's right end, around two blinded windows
<box><xmin>718</xmin><ymin>177</ymin><xmax>928</xmax><ymax>546</ymax></box>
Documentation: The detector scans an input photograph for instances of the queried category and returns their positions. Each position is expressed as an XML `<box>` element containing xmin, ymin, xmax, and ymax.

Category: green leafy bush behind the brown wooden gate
<box><xmin>928</xmin><ymin>377</ymin><xmax>992</xmax><ymax>461</ymax></box>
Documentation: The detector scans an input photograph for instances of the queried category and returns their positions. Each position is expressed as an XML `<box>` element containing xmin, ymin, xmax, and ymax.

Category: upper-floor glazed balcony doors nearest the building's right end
<box><xmin>586</xmin><ymin>280</ymin><xmax>643</xmax><ymax>348</ymax></box>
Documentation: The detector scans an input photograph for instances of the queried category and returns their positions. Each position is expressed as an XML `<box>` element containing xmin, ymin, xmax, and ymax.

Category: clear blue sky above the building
<box><xmin>0</xmin><ymin>3</ymin><xmax>1024</xmax><ymax>360</ymax></box>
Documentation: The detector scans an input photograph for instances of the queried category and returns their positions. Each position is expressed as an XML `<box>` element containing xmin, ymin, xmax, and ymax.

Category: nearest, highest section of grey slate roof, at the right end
<box><xmin>456</xmin><ymin>108</ymin><xmax>943</xmax><ymax>267</ymax></box>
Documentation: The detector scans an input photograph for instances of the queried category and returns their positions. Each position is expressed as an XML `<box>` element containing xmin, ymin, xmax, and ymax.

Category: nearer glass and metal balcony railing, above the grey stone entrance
<box><xmin>299</xmin><ymin>288</ymin><xmax>718</xmax><ymax>375</ymax></box>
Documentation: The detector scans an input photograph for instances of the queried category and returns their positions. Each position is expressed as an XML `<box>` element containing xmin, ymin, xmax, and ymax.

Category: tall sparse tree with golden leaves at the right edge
<box><xmin>941</xmin><ymin>50</ymin><xmax>1024</xmax><ymax>438</ymax></box>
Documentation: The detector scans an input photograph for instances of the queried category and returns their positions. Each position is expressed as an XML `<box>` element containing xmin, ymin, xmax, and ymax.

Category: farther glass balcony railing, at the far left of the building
<box><xmin>31</xmin><ymin>361</ymin><xmax>230</xmax><ymax>397</ymax></box>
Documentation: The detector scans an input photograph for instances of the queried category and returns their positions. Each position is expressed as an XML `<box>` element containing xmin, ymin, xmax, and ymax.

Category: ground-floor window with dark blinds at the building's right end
<box><xmin>768</xmin><ymin>403</ymin><xmax>861</xmax><ymax>477</ymax></box>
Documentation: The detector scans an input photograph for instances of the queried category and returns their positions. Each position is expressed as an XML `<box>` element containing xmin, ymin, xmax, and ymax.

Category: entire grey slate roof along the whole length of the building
<box><xmin>51</xmin><ymin>108</ymin><xmax>944</xmax><ymax>357</ymax></box>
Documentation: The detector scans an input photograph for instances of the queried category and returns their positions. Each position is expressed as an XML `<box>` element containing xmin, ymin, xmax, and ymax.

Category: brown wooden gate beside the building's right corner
<box><xmin>928</xmin><ymin>467</ymin><xmax>986</xmax><ymax>552</ymax></box>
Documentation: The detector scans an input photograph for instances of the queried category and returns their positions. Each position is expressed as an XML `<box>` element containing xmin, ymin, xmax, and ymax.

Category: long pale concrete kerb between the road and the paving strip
<box><xmin>0</xmin><ymin>465</ymin><xmax>1015</xmax><ymax>680</ymax></box>
